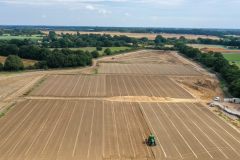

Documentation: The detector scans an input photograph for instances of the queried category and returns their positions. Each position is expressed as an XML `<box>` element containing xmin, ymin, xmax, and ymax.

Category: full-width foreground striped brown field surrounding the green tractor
<box><xmin>0</xmin><ymin>100</ymin><xmax>240</xmax><ymax>160</ymax></box>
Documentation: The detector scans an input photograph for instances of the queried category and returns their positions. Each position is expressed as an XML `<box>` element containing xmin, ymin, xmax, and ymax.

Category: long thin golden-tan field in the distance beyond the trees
<box><xmin>42</xmin><ymin>31</ymin><xmax>220</xmax><ymax>40</ymax></box>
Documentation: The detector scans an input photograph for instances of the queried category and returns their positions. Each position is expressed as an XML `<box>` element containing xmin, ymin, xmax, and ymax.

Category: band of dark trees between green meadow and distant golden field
<box><xmin>42</xmin><ymin>31</ymin><xmax>138</xmax><ymax>48</ymax></box>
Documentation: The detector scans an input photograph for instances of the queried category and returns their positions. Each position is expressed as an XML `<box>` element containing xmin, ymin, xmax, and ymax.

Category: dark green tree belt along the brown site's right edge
<box><xmin>175</xmin><ymin>43</ymin><xmax>240</xmax><ymax>97</ymax></box>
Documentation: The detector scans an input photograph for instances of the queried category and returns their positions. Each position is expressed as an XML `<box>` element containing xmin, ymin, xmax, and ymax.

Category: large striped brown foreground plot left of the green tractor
<box><xmin>0</xmin><ymin>100</ymin><xmax>153</xmax><ymax>160</ymax></box>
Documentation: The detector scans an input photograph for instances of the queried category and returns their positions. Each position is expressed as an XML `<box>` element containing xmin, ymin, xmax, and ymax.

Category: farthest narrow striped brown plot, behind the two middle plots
<box><xmin>99</xmin><ymin>63</ymin><xmax>201</xmax><ymax>76</ymax></box>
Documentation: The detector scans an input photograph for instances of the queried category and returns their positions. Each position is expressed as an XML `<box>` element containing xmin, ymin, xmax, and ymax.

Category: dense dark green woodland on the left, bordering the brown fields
<box><xmin>0</xmin><ymin>44</ymin><xmax>92</xmax><ymax>68</ymax></box>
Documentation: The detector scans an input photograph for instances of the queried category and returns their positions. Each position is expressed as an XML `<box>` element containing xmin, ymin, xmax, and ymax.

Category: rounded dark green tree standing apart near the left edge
<box><xmin>4</xmin><ymin>55</ymin><xmax>24</xmax><ymax>71</ymax></box>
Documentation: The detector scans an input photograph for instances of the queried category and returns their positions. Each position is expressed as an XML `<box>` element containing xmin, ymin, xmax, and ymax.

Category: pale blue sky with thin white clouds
<box><xmin>0</xmin><ymin>0</ymin><xmax>240</xmax><ymax>29</ymax></box>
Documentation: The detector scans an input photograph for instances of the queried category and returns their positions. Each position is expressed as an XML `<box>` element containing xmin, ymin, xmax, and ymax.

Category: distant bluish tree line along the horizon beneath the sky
<box><xmin>5</xmin><ymin>26</ymin><xmax>236</xmax><ymax>36</ymax></box>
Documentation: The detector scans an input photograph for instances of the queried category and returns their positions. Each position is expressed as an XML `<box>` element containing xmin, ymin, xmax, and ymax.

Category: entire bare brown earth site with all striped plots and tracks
<box><xmin>0</xmin><ymin>50</ymin><xmax>240</xmax><ymax>160</ymax></box>
